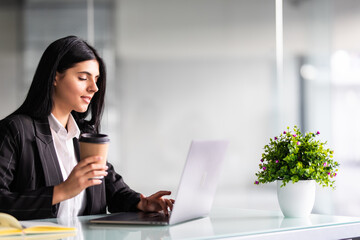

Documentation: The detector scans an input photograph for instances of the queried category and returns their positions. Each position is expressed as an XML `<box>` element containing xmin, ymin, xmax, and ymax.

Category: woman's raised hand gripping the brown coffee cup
<box><xmin>52</xmin><ymin>156</ymin><xmax>108</xmax><ymax>205</ymax></box>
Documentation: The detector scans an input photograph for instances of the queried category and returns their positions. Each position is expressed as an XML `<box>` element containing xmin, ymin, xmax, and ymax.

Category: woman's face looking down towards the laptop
<box><xmin>53</xmin><ymin>60</ymin><xmax>99</xmax><ymax>113</ymax></box>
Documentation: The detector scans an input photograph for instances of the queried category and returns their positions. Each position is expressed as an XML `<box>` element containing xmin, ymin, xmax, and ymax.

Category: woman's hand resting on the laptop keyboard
<box><xmin>137</xmin><ymin>191</ymin><xmax>175</xmax><ymax>215</ymax></box>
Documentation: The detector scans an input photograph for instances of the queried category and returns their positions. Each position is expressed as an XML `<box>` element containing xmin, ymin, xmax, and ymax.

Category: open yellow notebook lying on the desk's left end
<box><xmin>0</xmin><ymin>213</ymin><xmax>76</xmax><ymax>239</ymax></box>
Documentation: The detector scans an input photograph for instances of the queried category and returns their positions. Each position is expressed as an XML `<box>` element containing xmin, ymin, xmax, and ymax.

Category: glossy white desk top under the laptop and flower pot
<box><xmin>40</xmin><ymin>208</ymin><xmax>360</xmax><ymax>240</ymax></box>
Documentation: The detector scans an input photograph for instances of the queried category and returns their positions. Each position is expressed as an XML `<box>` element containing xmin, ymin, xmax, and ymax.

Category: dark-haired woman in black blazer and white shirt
<box><xmin>0</xmin><ymin>36</ymin><xmax>174</xmax><ymax>220</ymax></box>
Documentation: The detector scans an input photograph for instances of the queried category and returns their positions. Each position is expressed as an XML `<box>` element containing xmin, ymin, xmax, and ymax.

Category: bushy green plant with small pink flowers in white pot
<box><xmin>255</xmin><ymin>126</ymin><xmax>339</xmax><ymax>217</ymax></box>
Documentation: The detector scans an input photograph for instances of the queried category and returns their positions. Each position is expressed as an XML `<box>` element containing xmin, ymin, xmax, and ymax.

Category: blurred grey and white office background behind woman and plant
<box><xmin>0</xmin><ymin>0</ymin><xmax>360</xmax><ymax>216</ymax></box>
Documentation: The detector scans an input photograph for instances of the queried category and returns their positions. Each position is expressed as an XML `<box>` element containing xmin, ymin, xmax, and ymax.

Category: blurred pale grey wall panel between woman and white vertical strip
<box><xmin>116</xmin><ymin>0</ymin><xmax>282</xmax><ymax>211</ymax></box>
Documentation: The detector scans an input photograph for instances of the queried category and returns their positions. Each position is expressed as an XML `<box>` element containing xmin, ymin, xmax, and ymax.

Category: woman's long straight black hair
<box><xmin>12</xmin><ymin>36</ymin><xmax>106</xmax><ymax>132</ymax></box>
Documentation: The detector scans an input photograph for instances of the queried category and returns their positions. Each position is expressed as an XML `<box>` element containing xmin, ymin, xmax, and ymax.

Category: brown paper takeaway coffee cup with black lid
<box><xmin>79</xmin><ymin>133</ymin><xmax>110</xmax><ymax>175</ymax></box>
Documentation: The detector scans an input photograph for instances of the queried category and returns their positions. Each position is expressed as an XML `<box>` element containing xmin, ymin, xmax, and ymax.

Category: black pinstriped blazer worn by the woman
<box><xmin>0</xmin><ymin>115</ymin><xmax>140</xmax><ymax>220</ymax></box>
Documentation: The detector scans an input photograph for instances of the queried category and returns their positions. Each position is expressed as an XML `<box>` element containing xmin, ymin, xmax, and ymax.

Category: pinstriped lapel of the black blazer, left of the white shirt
<box><xmin>34</xmin><ymin>118</ymin><xmax>64</xmax><ymax>186</ymax></box>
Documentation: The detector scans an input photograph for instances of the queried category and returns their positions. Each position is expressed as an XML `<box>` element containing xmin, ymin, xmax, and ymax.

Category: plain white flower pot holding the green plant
<box><xmin>277</xmin><ymin>180</ymin><xmax>316</xmax><ymax>218</ymax></box>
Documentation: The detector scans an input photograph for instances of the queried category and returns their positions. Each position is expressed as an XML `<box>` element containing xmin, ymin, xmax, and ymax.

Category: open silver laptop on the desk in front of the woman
<box><xmin>90</xmin><ymin>140</ymin><xmax>228</xmax><ymax>225</ymax></box>
